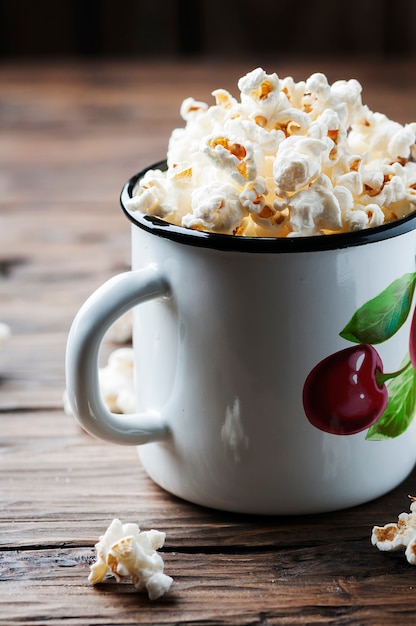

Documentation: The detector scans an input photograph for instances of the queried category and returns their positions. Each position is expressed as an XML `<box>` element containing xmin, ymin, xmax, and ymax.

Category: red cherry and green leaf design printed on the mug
<box><xmin>302</xmin><ymin>272</ymin><xmax>416</xmax><ymax>441</ymax></box>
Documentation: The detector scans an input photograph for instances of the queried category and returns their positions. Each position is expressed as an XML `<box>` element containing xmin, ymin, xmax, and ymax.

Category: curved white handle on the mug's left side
<box><xmin>66</xmin><ymin>266</ymin><xmax>169</xmax><ymax>445</ymax></box>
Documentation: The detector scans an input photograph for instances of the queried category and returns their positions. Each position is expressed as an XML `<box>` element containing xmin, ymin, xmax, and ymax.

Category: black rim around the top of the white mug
<box><xmin>120</xmin><ymin>160</ymin><xmax>416</xmax><ymax>253</ymax></box>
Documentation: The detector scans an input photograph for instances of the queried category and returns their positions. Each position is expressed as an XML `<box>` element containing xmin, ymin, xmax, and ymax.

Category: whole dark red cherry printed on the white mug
<box><xmin>303</xmin><ymin>344</ymin><xmax>388</xmax><ymax>435</ymax></box>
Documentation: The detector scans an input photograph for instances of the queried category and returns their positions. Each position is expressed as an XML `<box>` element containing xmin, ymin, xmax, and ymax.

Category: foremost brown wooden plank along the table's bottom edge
<box><xmin>0</xmin><ymin>541</ymin><xmax>416</xmax><ymax>626</ymax></box>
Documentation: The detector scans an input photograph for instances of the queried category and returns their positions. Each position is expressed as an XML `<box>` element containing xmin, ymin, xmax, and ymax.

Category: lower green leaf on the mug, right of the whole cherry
<box><xmin>366</xmin><ymin>355</ymin><xmax>416</xmax><ymax>441</ymax></box>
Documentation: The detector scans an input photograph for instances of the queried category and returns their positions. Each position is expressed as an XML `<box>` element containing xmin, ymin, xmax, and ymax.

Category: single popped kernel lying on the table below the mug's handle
<box><xmin>88</xmin><ymin>519</ymin><xmax>173</xmax><ymax>600</ymax></box>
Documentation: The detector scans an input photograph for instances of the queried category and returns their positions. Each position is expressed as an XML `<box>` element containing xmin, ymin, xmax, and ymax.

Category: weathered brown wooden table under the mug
<box><xmin>0</xmin><ymin>60</ymin><xmax>416</xmax><ymax>626</ymax></box>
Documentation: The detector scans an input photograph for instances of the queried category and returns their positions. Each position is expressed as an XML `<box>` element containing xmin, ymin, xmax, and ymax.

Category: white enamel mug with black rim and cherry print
<box><xmin>66</xmin><ymin>166</ymin><xmax>416</xmax><ymax>515</ymax></box>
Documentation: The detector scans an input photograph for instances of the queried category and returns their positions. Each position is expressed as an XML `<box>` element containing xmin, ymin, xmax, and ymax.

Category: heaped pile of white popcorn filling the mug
<box><xmin>127</xmin><ymin>68</ymin><xmax>416</xmax><ymax>237</ymax></box>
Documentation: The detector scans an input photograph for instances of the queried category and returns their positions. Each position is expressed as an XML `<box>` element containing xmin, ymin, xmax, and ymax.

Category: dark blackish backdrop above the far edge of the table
<box><xmin>0</xmin><ymin>0</ymin><xmax>416</xmax><ymax>59</ymax></box>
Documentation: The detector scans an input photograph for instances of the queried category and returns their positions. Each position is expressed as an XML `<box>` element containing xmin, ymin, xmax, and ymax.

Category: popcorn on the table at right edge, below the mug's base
<box><xmin>371</xmin><ymin>496</ymin><xmax>416</xmax><ymax>565</ymax></box>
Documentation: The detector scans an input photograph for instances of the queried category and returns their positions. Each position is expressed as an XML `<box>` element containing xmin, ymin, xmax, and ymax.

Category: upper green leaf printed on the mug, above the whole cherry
<box><xmin>340</xmin><ymin>272</ymin><xmax>416</xmax><ymax>345</ymax></box>
